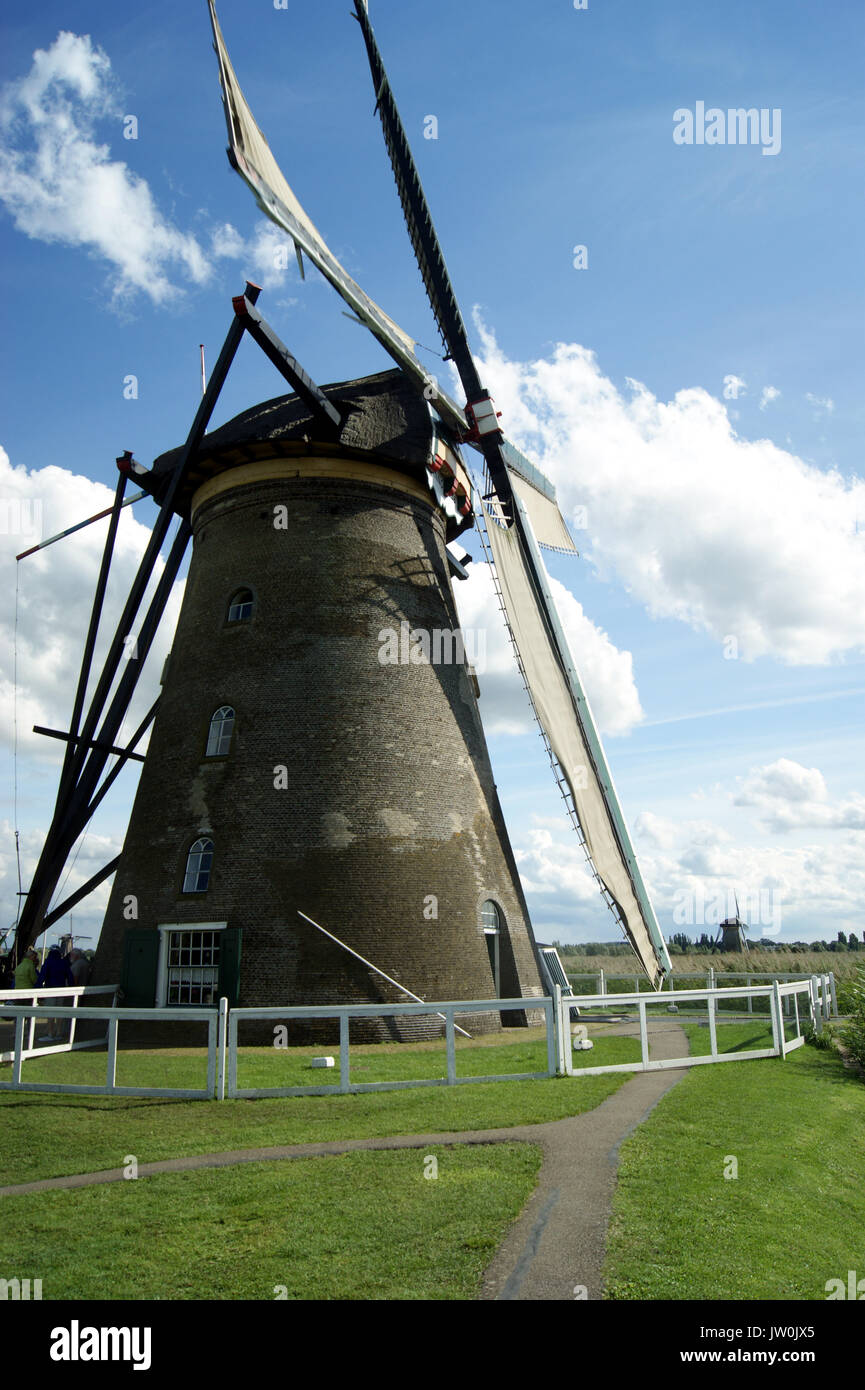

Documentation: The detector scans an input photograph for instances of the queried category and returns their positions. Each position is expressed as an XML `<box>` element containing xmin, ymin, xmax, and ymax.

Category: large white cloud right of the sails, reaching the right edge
<box><xmin>477</xmin><ymin>320</ymin><xmax>865</xmax><ymax>664</ymax></box>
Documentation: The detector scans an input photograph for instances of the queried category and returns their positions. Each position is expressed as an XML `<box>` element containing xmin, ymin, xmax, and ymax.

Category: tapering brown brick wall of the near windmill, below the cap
<box><xmin>93</xmin><ymin>460</ymin><xmax>542</xmax><ymax>1037</ymax></box>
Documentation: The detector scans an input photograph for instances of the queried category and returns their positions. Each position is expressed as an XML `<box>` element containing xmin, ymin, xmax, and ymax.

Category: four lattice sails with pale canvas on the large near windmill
<box><xmin>209</xmin><ymin>0</ymin><xmax>670</xmax><ymax>984</ymax></box>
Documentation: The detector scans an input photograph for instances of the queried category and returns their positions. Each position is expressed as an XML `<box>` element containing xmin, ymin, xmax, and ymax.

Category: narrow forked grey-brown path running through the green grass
<box><xmin>0</xmin><ymin>1020</ymin><xmax>688</xmax><ymax>1301</ymax></box>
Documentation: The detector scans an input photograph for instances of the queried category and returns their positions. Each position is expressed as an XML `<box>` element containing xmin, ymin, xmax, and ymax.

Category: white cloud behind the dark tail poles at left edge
<box><xmin>0</xmin><ymin>448</ymin><xmax>184</xmax><ymax>924</ymax></box>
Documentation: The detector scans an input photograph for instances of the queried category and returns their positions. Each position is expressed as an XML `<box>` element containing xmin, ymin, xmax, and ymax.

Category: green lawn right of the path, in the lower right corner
<box><xmin>605</xmin><ymin>1022</ymin><xmax>865</xmax><ymax>1300</ymax></box>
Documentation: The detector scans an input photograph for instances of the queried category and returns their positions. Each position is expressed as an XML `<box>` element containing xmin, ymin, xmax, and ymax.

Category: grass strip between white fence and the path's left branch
<box><xmin>0</xmin><ymin>1037</ymin><xmax>638</xmax><ymax>1184</ymax></box>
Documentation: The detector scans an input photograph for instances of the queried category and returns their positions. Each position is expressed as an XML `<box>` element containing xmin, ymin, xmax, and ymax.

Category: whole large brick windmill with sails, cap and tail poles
<box><xmin>17</xmin><ymin>0</ymin><xmax>670</xmax><ymax>1027</ymax></box>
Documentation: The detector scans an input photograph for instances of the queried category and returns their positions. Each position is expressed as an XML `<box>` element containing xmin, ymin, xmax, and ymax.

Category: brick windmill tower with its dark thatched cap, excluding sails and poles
<box><xmin>91</xmin><ymin>366</ymin><xmax>541</xmax><ymax>1027</ymax></box>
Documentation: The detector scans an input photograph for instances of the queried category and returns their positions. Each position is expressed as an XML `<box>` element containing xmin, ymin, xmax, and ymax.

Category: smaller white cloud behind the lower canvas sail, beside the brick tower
<box><xmin>455</xmin><ymin>550</ymin><xmax>642</xmax><ymax>734</ymax></box>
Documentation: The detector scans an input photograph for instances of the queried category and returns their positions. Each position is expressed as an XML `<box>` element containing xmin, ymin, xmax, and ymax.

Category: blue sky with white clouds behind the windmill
<box><xmin>0</xmin><ymin>0</ymin><xmax>865</xmax><ymax>940</ymax></box>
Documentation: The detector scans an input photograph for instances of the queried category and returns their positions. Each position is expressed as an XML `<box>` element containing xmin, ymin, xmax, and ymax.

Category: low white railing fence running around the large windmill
<box><xmin>0</xmin><ymin>976</ymin><xmax>833</xmax><ymax>1101</ymax></box>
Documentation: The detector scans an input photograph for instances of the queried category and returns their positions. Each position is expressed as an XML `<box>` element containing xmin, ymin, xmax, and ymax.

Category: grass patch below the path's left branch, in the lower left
<box><xmin>0</xmin><ymin>1144</ymin><xmax>541</xmax><ymax>1301</ymax></box>
